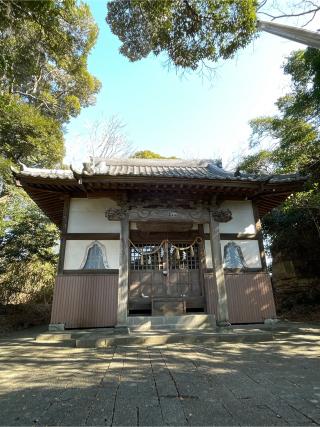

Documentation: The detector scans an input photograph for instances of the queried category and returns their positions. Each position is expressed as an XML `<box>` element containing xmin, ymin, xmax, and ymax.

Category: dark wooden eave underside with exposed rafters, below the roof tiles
<box><xmin>14</xmin><ymin>173</ymin><xmax>306</xmax><ymax>227</ymax></box>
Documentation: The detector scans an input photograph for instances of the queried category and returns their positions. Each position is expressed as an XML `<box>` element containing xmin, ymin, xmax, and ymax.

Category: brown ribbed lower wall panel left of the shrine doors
<box><xmin>51</xmin><ymin>274</ymin><xmax>118</xmax><ymax>328</ymax></box>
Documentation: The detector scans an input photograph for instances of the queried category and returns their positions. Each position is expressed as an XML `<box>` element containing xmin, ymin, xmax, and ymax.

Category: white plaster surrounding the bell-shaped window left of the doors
<box><xmin>64</xmin><ymin>240</ymin><xmax>120</xmax><ymax>270</ymax></box>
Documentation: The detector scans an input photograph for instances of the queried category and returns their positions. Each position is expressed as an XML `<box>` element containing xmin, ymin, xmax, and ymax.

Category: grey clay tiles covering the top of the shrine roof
<box><xmin>15</xmin><ymin>158</ymin><xmax>305</xmax><ymax>183</ymax></box>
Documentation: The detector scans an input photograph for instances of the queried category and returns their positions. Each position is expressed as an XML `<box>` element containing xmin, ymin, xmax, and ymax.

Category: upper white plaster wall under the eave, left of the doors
<box><xmin>68</xmin><ymin>197</ymin><xmax>120</xmax><ymax>233</ymax></box>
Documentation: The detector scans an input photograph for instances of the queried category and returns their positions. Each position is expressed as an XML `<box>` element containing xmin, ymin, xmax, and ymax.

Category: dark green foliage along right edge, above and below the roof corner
<box><xmin>238</xmin><ymin>49</ymin><xmax>320</xmax><ymax>275</ymax></box>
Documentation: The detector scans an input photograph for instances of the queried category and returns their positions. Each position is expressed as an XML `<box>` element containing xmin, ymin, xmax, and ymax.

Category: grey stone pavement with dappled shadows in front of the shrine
<box><xmin>0</xmin><ymin>326</ymin><xmax>320</xmax><ymax>426</ymax></box>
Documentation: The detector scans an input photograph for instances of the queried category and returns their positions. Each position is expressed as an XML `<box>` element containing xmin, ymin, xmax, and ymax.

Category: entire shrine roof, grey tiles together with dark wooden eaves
<box><xmin>13</xmin><ymin>158</ymin><xmax>306</xmax><ymax>226</ymax></box>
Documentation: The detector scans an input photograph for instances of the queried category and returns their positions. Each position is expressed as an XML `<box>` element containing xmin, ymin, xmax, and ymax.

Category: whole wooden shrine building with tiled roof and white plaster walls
<box><xmin>14</xmin><ymin>158</ymin><xmax>305</xmax><ymax>330</ymax></box>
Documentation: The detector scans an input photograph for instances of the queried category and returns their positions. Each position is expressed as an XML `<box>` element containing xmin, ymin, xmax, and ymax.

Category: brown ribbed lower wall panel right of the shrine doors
<box><xmin>205</xmin><ymin>272</ymin><xmax>276</xmax><ymax>323</ymax></box>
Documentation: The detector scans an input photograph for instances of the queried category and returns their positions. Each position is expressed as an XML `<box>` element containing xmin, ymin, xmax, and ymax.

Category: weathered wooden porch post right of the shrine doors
<box><xmin>209</xmin><ymin>211</ymin><xmax>230</xmax><ymax>326</ymax></box>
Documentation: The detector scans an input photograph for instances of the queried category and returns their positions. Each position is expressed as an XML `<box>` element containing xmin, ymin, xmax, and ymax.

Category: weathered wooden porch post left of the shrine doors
<box><xmin>117</xmin><ymin>215</ymin><xmax>129</xmax><ymax>326</ymax></box>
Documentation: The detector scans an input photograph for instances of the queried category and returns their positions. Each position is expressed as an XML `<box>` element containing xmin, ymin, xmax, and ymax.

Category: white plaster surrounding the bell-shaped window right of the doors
<box><xmin>205</xmin><ymin>240</ymin><xmax>262</xmax><ymax>268</ymax></box>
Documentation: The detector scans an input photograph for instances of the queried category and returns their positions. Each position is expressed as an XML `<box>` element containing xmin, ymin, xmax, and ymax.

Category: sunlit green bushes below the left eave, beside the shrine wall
<box><xmin>0</xmin><ymin>190</ymin><xmax>59</xmax><ymax>304</ymax></box>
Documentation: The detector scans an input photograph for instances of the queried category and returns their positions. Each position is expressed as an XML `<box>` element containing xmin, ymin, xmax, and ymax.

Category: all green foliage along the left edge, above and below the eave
<box><xmin>0</xmin><ymin>0</ymin><xmax>100</xmax><ymax>303</ymax></box>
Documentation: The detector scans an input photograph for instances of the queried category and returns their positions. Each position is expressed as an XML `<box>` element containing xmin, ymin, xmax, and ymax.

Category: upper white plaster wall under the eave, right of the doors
<box><xmin>204</xmin><ymin>200</ymin><xmax>256</xmax><ymax>234</ymax></box>
